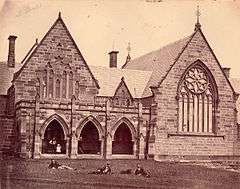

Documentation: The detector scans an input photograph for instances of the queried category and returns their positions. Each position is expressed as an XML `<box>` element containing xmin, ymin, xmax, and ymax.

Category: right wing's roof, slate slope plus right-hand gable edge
<box><xmin>123</xmin><ymin>28</ymin><xmax>235</xmax><ymax>96</ymax></box>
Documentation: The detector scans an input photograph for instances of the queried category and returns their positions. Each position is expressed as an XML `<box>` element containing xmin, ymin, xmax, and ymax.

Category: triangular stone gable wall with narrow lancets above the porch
<box><xmin>13</xmin><ymin>18</ymin><xmax>98</xmax><ymax>102</ymax></box>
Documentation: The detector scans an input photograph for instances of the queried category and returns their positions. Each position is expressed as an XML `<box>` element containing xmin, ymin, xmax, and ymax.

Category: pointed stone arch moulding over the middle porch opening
<box><xmin>76</xmin><ymin>115</ymin><xmax>104</xmax><ymax>140</ymax></box>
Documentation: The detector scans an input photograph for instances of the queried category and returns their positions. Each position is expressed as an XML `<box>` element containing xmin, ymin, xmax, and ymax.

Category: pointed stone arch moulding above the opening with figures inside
<box><xmin>39</xmin><ymin>114</ymin><xmax>69</xmax><ymax>140</ymax></box>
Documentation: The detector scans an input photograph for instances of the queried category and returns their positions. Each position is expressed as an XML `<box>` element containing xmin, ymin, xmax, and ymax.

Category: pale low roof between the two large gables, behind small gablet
<box><xmin>90</xmin><ymin>66</ymin><xmax>152</xmax><ymax>98</ymax></box>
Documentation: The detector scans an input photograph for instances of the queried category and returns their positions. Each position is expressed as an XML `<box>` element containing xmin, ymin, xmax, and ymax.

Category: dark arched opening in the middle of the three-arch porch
<box><xmin>78</xmin><ymin>121</ymin><xmax>101</xmax><ymax>154</ymax></box>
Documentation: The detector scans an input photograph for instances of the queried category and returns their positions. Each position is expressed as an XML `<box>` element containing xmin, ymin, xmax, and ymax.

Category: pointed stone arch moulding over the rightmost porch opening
<box><xmin>110</xmin><ymin>117</ymin><xmax>137</xmax><ymax>141</ymax></box>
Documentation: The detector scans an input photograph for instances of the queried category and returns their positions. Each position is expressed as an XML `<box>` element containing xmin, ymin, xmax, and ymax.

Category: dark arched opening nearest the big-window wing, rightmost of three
<box><xmin>112</xmin><ymin>123</ymin><xmax>133</xmax><ymax>154</ymax></box>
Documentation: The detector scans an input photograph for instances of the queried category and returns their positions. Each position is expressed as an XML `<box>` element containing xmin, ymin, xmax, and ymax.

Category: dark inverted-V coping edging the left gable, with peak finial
<box><xmin>14</xmin><ymin>12</ymin><xmax>99</xmax><ymax>88</ymax></box>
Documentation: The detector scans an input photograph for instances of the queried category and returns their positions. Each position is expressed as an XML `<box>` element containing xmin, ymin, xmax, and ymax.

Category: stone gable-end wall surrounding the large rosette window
<box><xmin>155</xmin><ymin>30</ymin><xmax>237</xmax><ymax>159</ymax></box>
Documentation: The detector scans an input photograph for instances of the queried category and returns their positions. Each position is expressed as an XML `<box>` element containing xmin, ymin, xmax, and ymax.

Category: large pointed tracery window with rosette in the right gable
<box><xmin>178</xmin><ymin>63</ymin><xmax>217</xmax><ymax>133</ymax></box>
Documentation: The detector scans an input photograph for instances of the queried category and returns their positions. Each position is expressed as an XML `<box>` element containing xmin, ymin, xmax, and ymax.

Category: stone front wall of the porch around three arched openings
<box><xmin>17</xmin><ymin>100</ymin><xmax>150</xmax><ymax>158</ymax></box>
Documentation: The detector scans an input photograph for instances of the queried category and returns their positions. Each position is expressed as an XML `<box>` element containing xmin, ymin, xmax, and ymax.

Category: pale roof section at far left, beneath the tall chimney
<box><xmin>0</xmin><ymin>62</ymin><xmax>22</xmax><ymax>95</ymax></box>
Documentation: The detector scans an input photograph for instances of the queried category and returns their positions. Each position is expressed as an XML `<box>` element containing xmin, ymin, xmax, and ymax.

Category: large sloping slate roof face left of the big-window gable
<box><xmin>123</xmin><ymin>35</ymin><xmax>192</xmax><ymax>96</ymax></box>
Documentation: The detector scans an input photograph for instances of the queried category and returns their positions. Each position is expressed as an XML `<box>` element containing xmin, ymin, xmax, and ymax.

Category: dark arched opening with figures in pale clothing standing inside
<box><xmin>42</xmin><ymin>119</ymin><xmax>66</xmax><ymax>154</ymax></box>
